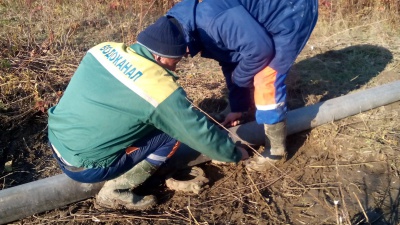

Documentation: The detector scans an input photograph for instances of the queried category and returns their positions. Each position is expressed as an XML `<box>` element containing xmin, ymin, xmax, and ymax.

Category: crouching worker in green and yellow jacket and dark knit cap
<box><xmin>48</xmin><ymin>17</ymin><xmax>248</xmax><ymax>210</ymax></box>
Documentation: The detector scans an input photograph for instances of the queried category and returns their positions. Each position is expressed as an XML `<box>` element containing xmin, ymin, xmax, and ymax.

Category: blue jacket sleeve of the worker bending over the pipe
<box><xmin>209</xmin><ymin>5</ymin><xmax>275</xmax><ymax>87</ymax></box>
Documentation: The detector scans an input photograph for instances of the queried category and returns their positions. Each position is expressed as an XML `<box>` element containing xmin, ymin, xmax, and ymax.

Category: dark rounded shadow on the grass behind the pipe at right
<box><xmin>287</xmin><ymin>45</ymin><xmax>393</xmax><ymax>109</ymax></box>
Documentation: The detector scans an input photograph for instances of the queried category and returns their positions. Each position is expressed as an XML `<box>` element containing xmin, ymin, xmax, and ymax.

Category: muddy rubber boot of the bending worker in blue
<box><xmin>246</xmin><ymin>121</ymin><xmax>287</xmax><ymax>172</ymax></box>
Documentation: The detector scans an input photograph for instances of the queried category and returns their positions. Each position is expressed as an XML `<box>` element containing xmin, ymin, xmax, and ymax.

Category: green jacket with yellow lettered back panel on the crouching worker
<box><xmin>48</xmin><ymin>42</ymin><xmax>241</xmax><ymax>168</ymax></box>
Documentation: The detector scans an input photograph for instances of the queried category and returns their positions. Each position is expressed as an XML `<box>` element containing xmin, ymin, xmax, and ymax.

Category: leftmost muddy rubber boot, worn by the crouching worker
<box><xmin>96</xmin><ymin>160</ymin><xmax>157</xmax><ymax>210</ymax></box>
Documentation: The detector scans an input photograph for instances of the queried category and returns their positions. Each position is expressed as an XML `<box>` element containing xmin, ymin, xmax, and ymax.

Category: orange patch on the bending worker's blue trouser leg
<box><xmin>254</xmin><ymin>66</ymin><xmax>277</xmax><ymax>105</ymax></box>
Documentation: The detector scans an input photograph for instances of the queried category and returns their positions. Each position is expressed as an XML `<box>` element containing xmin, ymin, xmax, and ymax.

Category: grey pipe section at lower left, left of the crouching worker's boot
<box><xmin>0</xmin><ymin>174</ymin><xmax>103</xmax><ymax>224</ymax></box>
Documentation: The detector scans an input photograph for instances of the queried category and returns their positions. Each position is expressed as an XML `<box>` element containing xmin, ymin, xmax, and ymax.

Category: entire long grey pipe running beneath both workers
<box><xmin>0</xmin><ymin>81</ymin><xmax>400</xmax><ymax>224</ymax></box>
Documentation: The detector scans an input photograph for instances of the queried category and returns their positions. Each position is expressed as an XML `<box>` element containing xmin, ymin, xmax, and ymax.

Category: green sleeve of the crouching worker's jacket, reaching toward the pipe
<box><xmin>149</xmin><ymin>87</ymin><xmax>242</xmax><ymax>162</ymax></box>
